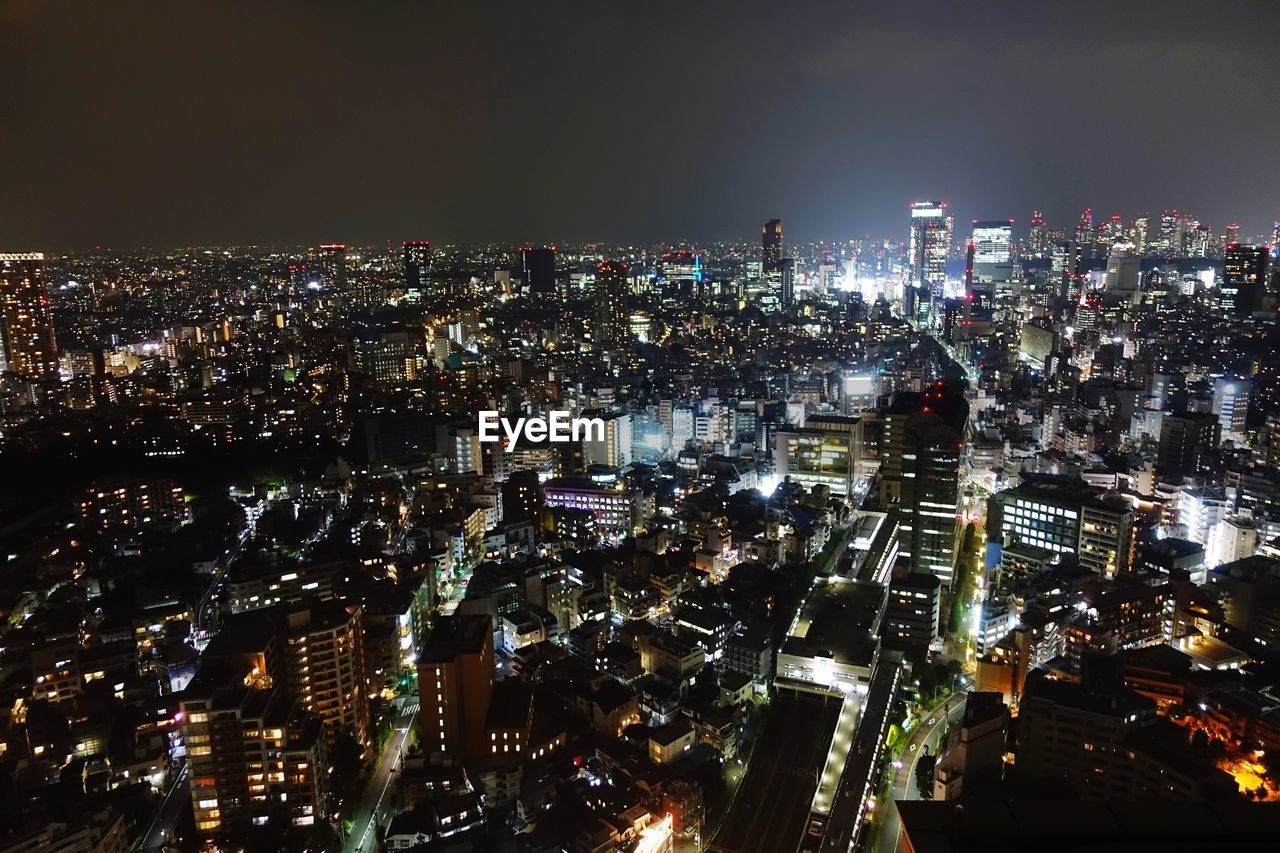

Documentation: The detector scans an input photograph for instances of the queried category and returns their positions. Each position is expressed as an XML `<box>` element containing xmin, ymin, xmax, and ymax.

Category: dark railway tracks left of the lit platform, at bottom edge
<box><xmin>709</xmin><ymin>690</ymin><xmax>841</xmax><ymax>853</ymax></box>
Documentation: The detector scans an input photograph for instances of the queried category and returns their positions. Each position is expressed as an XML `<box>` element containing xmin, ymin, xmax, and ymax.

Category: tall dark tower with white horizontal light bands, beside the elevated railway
<box><xmin>879</xmin><ymin>383</ymin><xmax>969</xmax><ymax>578</ymax></box>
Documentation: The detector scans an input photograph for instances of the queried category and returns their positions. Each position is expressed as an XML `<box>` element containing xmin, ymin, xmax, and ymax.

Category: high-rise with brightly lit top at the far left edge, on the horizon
<box><xmin>0</xmin><ymin>252</ymin><xmax>58</xmax><ymax>380</ymax></box>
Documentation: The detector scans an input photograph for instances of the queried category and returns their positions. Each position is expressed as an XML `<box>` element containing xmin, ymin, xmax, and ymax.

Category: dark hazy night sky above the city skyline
<box><xmin>0</xmin><ymin>0</ymin><xmax>1280</xmax><ymax>251</ymax></box>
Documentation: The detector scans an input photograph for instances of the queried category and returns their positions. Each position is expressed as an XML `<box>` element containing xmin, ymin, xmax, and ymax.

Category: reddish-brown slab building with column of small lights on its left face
<box><xmin>417</xmin><ymin>615</ymin><xmax>494</xmax><ymax>767</ymax></box>
